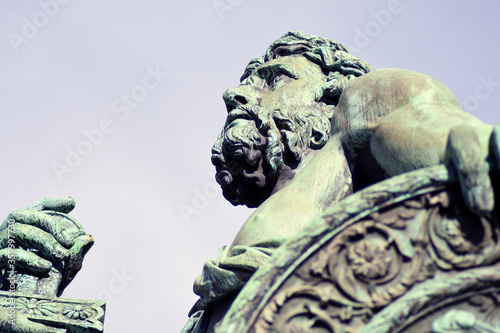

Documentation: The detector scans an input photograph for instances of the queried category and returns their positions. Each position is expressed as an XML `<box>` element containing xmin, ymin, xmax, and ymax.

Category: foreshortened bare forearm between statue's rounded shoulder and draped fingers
<box><xmin>370</xmin><ymin>103</ymin><xmax>492</xmax><ymax>176</ymax></box>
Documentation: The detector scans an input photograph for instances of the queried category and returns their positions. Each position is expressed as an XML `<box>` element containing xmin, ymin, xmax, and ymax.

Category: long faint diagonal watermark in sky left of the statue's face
<box><xmin>51</xmin><ymin>65</ymin><xmax>169</xmax><ymax>182</ymax></box>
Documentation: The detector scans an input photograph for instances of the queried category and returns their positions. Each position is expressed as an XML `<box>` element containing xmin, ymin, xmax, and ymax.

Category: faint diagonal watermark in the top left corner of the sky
<box><xmin>7</xmin><ymin>0</ymin><xmax>71</xmax><ymax>53</ymax></box>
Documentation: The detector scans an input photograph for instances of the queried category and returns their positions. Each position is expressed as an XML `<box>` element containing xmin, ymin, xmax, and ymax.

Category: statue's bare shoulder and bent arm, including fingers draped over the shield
<box><xmin>332</xmin><ymin>69</ymin><xmax>492</xmax><ymax>215</ymax></box>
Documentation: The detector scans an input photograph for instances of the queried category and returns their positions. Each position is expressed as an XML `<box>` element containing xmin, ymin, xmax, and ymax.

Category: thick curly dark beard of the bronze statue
<box><xmin>212</xmin><ymin>105</ymin><xmax>330</xmax><ymax>208</ymax></box>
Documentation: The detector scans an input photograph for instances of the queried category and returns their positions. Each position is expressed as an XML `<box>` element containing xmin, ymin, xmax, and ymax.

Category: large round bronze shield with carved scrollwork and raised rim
<box><xmin>218</xmin><ymin>166</ymin><xmax>500</xmax><ymax>333</ymax></box>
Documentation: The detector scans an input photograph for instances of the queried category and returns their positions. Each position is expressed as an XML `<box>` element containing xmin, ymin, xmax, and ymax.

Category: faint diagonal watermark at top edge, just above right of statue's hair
<box><xmin>343</xmin><ymin>0</ymin><xmax>411</xmax><ymax>53</ymax></box>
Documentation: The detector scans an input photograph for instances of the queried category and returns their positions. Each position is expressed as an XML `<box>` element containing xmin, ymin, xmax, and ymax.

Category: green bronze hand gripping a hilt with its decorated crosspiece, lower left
<box><xmin>0</xmin><ymin>198</ymin><xmax>105</xmax><ymax>333</ymax></box>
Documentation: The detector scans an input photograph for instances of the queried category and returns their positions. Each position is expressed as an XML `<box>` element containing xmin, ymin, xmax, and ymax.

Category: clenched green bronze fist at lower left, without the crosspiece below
<box><xmin>0</xmin><ymin>197</ymin><xmax>93</xmax><ymax>296</ymax></box>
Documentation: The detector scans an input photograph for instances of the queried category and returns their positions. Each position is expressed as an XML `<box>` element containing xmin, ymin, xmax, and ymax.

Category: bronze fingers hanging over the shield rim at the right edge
<box><xmin>446</xmin><ymin>125</ymin><xmax>500</xmax><ymax>216</ymax></box>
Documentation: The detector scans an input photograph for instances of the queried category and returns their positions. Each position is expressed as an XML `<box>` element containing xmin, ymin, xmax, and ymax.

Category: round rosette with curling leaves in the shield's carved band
<box><xmin>322</xmin><ymin>220</ymin><xmax>424</xmax><ymax>308</ymax></box>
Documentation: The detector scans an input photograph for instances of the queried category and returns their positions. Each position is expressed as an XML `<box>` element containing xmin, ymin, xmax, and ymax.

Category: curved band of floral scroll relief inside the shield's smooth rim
<box><xmin>247</xmin><ymin>184</ymin><xmax>500</xmax><ymax>333</ymax></box>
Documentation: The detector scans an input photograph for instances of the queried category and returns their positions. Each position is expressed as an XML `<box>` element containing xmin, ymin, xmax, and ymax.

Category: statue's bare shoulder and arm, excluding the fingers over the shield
<box><xmin>333</xmin><ymin>69</ymin><xmax>492</xmax><ymax>176</ymax></box>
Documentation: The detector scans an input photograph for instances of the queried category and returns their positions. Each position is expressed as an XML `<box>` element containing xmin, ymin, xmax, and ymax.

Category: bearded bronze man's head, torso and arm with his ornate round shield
<box><xmin>184</xmin><ymin>31</ymin><xmax>500</xmax><ymax>332</ymax></box>
